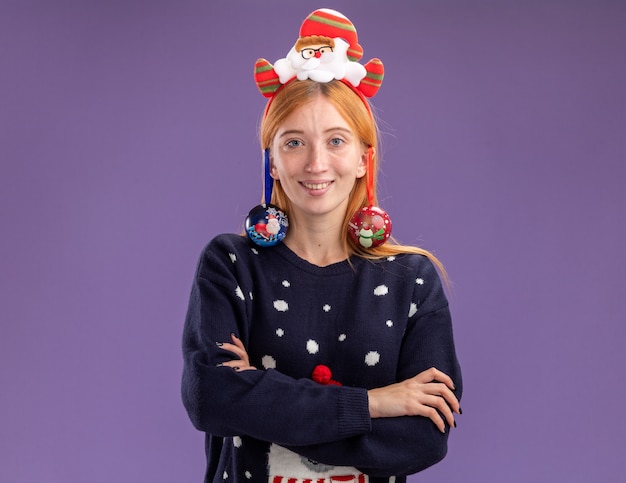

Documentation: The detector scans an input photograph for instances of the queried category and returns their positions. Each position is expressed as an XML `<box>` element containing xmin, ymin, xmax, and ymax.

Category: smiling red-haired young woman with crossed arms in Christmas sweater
<box><xmin>182</xmin><ymin>10</ymin><xmax>461</xmax><ymax>483</ymax></box>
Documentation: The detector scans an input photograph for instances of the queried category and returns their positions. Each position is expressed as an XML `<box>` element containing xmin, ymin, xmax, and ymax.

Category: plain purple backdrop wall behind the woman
<box><xmin>0</xmin><ymin>0</ymin><xmax>626</xmax><ymax>483</ymax></box>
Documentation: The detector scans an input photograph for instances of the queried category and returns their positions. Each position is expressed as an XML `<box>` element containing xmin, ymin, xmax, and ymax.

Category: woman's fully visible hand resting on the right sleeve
<box><xmin>367</xmin><ymin>367</ymin><xmax>461</xmax><ymax>433</ymax></box>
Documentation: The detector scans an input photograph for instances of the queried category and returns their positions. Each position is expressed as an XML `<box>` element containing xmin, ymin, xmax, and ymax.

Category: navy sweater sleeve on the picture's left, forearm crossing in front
<box><xmin>182</xmin><ymin>238</ymin><xmax>371</xmax><ymax>446</ymax></box>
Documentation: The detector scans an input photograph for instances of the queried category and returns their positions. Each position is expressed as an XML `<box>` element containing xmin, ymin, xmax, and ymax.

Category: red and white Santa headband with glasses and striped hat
<box><xmin>254</xmin><ymin>8</ymin><xmax>384</xmax><ymax>112</ymax></box>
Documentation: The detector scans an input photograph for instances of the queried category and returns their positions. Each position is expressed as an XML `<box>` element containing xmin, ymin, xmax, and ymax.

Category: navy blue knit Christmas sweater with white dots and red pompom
<box><xmin>182</xmin><ymin>234</ymin><xmax>462</xmax><ymax>483</ymax></box>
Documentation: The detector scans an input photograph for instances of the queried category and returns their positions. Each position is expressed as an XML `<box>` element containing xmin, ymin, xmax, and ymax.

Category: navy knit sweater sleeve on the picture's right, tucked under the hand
<box><xmin>290</xmin><ymin>263</ymin><xmax>462</xmax><ymax>477</ymax></box>
